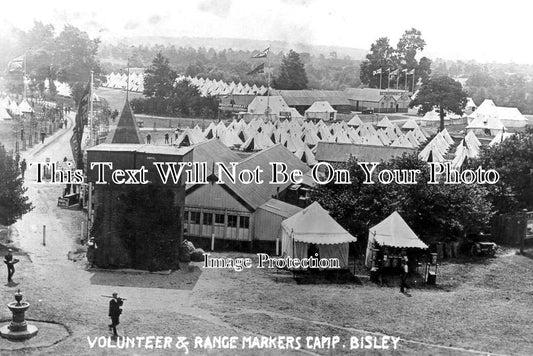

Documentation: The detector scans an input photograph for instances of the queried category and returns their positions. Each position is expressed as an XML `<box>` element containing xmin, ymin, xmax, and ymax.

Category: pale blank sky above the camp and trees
<box><xmin>0</xmin><ymin>0</ymin><xmax>533</xmax><ymax>64</ymax></box>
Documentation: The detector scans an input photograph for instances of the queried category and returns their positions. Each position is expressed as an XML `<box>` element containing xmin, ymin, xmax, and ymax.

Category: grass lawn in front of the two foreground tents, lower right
<box><xmin>190</xmin><ymin>249</ymin><xmax>533</xmax><ymax>355</ymax></box>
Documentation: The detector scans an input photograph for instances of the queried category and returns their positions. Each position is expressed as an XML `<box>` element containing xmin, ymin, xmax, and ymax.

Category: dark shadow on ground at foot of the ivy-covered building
<box><xmin>90</xmin><ymin>266</ymin><xmax>202</xmax><ymax>290</ymax></box>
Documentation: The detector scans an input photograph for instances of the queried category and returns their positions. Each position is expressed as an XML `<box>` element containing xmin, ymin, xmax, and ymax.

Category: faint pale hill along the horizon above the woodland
<box><xmin>104</xmin><ymin>36</ymin><xmax>368</xmax><ymax>60</ymax></box>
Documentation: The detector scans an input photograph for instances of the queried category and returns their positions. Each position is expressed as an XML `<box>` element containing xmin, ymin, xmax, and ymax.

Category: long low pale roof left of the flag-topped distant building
<box><xmin>273</xmin><ymin>90</ymin><xmax>351</xmax><ymax>106</ymax></box>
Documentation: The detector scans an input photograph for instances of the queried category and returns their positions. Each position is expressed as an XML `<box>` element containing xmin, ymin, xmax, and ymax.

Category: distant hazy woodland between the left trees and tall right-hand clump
<box><xmin>99</xmin><ymin>44</ymin><xmax>361</xmax><ymax>90</ymax></box>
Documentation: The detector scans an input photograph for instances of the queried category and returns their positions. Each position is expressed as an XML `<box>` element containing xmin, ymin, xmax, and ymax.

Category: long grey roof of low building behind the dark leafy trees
<box><xmin>315</xmin><ymin>141</ymin><xmax>416</xmax><ymax>162</ymax></box>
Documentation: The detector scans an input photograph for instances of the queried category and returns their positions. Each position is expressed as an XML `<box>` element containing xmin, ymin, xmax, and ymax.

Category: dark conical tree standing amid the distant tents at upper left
<box><xmin>143</xmin><ymin>52</ymin><xmax>178</xmax><ymax>98</ymax></box>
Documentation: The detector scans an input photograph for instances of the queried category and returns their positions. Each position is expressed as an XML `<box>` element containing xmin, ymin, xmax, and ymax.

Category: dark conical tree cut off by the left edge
<box><xmin>0</xmin><ymin>145</ymin><xmax>33</xmax><ymax>226</ymax></box>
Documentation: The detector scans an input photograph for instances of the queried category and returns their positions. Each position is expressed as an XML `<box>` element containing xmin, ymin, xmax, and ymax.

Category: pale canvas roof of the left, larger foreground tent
<box><xmin>281</xmin><ymin>202</ymin><xmax>357</xmax><ymax>245</ymax></box>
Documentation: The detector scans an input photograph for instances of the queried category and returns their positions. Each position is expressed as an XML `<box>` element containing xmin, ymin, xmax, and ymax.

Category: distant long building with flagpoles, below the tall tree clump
<box><xmin>345</xmin><ymin>88</ymin><xmax>411</xmax><ymax>113</ymax></box>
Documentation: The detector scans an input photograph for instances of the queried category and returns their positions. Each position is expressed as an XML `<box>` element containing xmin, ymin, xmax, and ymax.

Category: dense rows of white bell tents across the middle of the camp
<box><xmin>174</xmin><ymin>116</ymin><xmax>428</xmax><ymax>165</ymax></box>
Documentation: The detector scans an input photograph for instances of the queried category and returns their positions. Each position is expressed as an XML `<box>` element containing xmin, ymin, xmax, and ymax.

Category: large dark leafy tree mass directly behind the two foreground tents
<box><xmin>312</xmin><ymin>154</ymin><xmax>492</xmax><ymax>247</ymax></box>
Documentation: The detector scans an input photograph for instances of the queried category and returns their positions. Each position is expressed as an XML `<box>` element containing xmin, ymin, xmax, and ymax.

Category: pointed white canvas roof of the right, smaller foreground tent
<box><xmin>368</xmin><ymin>211</ymin><xmax>428</xmax><ymax>249</ymax></box>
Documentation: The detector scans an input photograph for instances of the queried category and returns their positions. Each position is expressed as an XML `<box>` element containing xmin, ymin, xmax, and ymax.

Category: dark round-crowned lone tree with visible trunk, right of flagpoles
<box><xmin>410</xmin><ymin>76</ymin><xmax>467</xmax><ymax>131</ymax></box>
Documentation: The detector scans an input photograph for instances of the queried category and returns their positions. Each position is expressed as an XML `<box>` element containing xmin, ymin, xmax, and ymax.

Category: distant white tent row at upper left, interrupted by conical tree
<box><xmin>102</xmin><ymin>72</ymin><xmax>267</xmax><ymax>96</ymax></box>
